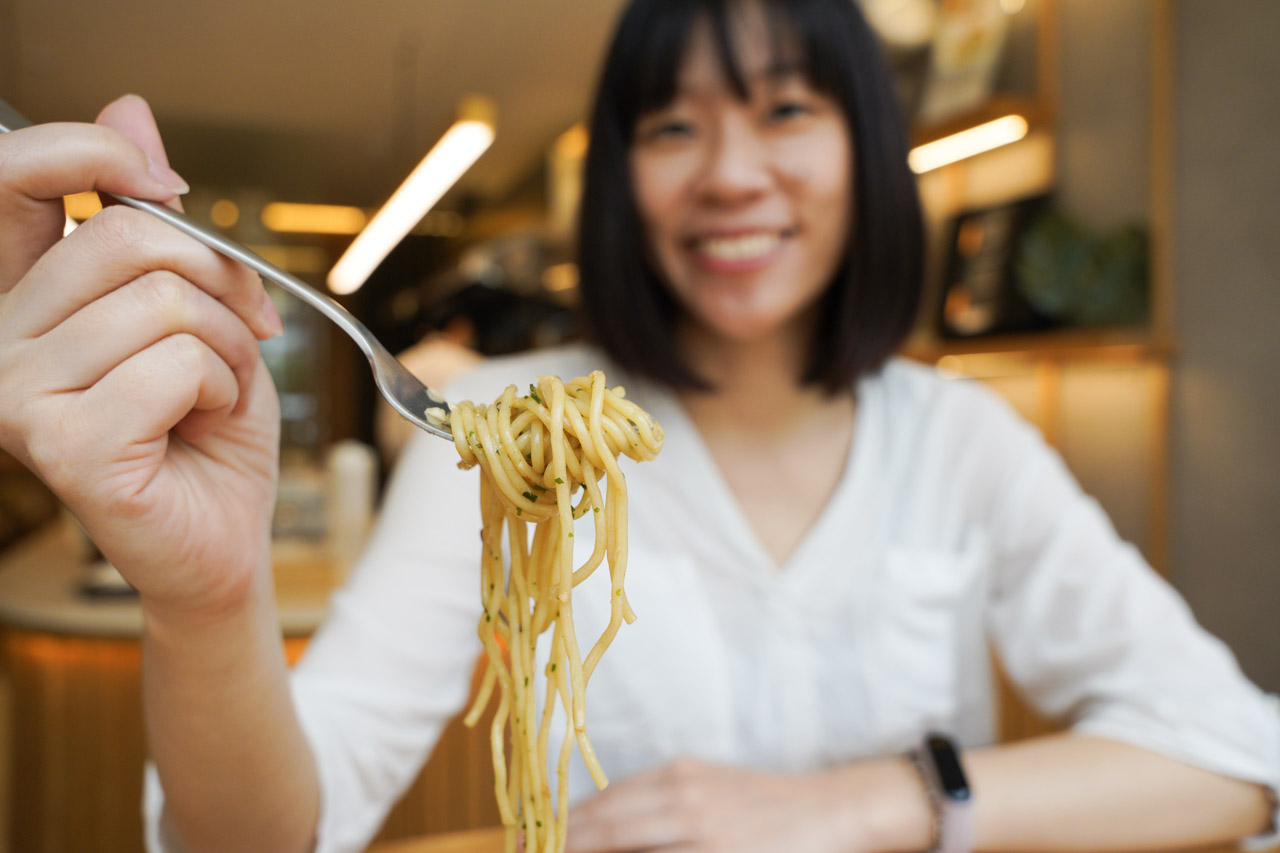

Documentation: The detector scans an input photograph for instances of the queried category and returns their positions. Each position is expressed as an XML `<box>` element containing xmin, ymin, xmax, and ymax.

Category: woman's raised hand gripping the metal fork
<box><xmin>0</xmin><ymin>96</ymin><xmax>280</xmax><ymax>611</ymax></box>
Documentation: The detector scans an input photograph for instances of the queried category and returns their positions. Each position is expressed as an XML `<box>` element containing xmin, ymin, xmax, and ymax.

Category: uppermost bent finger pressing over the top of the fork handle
<box><xmin>0</xmin><ymin>116</ymin><xmax>186</xmax><ymax>293</ymax></box>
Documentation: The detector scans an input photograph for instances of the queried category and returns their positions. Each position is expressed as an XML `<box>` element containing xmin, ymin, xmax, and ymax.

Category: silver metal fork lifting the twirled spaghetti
<box><xmin>0</xmin><ymin>100</ymin><xmax>453</xmax><ymax>441</ymax></box>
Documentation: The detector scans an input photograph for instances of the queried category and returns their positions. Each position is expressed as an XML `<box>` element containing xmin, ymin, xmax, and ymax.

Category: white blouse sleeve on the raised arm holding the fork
<box><xmin>145</xmin><ymin>425</ymin><xmax>480</xmax><ymax>853</ymax></box>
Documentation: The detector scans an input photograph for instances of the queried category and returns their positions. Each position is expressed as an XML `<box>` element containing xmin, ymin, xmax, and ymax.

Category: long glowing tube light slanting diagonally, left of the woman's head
<box><xmin>329</xmin><ymin>99</ymin><xmax>494</xmax><ymax>293</ymax></box>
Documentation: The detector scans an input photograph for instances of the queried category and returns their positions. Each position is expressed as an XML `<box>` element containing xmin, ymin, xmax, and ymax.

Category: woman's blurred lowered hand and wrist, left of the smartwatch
<box><xmin>566</xmin><ymin>758</ymin><xmax>932</xmax><ymax>853</ymax></box>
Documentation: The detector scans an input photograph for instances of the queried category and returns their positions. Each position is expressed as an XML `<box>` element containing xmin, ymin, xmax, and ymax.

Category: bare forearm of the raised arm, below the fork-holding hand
<box><xmin>143</xmin><ymin>548</ymin><xmax>319</xmax><ymax>852</ymax></box>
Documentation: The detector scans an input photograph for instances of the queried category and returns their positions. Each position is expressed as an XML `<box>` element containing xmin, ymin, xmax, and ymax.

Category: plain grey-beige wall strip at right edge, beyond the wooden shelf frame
<box><xmin>1172</xmin><ymin>0</ymin><xmax>1280</xmax><ymax>692</ymax></box>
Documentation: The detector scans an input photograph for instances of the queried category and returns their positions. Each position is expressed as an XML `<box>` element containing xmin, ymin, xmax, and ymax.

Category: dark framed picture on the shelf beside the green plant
<box><xmin>938</xmin><ymin>196</ymin><xmax>1053</xmax><ymax>338</ymax></box>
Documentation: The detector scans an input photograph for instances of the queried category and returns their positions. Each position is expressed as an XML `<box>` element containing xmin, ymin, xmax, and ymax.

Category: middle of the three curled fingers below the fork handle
<box><xmin>40</xmin><ymin>272</ymin><xmax>259</xmax><ymax>407</ymax></box>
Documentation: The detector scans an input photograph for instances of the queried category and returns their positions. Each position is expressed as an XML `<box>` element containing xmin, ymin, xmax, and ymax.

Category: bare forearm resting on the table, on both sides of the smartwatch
<box><xmin>828</xmin><ymin>734</ymin><xmax>1271</xmax><ymax>853</ymax></box>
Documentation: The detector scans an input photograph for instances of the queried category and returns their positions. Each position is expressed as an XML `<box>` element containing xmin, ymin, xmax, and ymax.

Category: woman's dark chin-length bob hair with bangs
<box><xmin>577</xmin><ymin>0</ymin><xmax>924</xmax><ymax>393</ymax></box>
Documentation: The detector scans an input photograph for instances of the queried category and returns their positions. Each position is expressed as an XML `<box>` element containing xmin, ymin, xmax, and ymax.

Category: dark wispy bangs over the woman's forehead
<box><xmin>612</xmin><ymin>0</ymin><xmax>841</xmax><ymax>127</ymax></box>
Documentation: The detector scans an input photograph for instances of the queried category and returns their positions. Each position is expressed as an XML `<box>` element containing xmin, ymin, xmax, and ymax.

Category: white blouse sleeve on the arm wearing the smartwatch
<box><xmin>989</xmin><ymin>409</ymin><xmax>1280</xmax><ymax>841</ymax></box>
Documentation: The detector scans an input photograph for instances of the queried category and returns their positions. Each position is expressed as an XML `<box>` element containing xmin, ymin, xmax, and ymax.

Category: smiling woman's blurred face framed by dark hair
<box><xmin>631</xmin><ymin>6</ymin><xmax>852</xmax><ymax>343</ymax></box>
